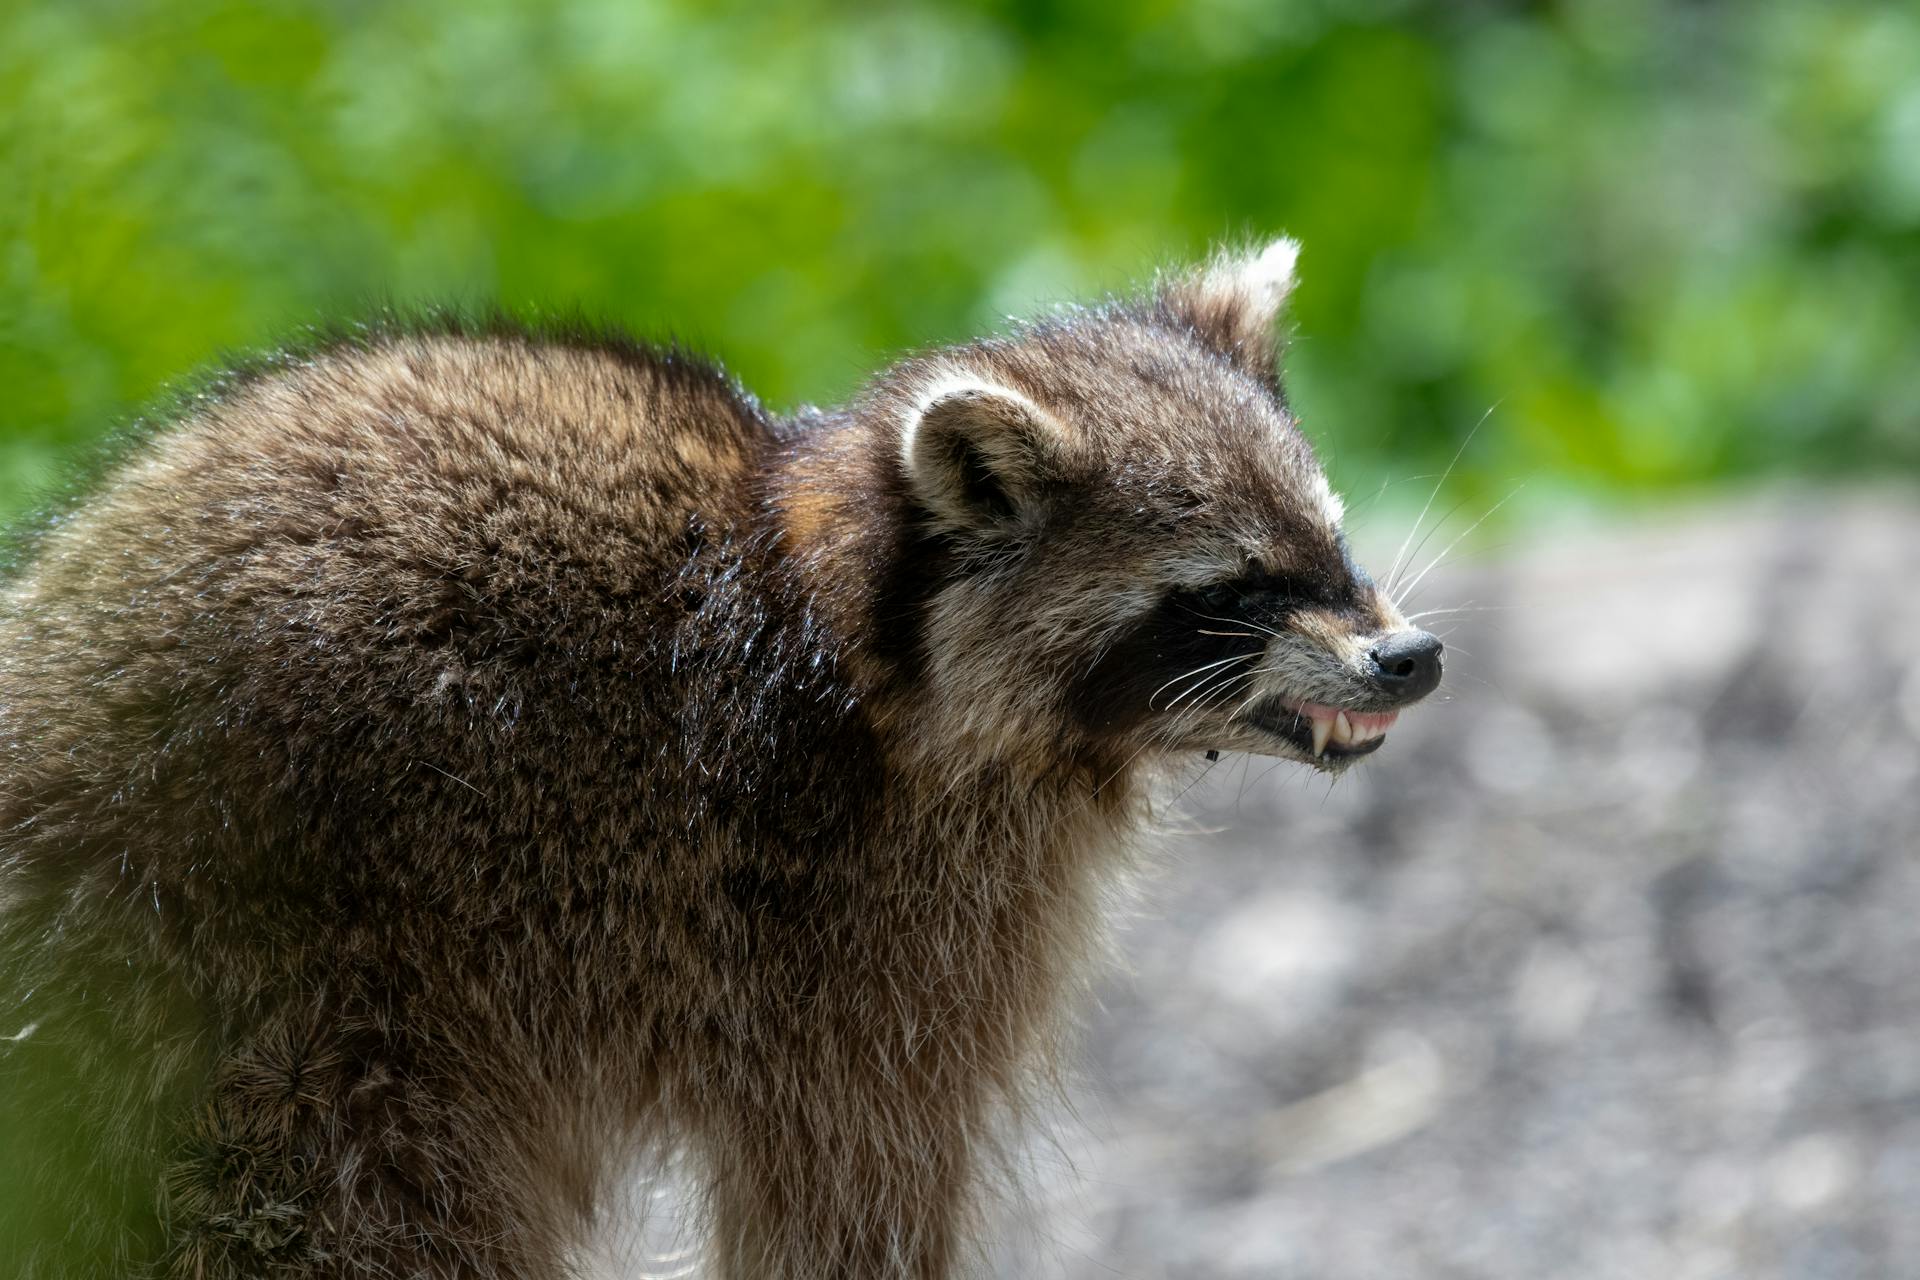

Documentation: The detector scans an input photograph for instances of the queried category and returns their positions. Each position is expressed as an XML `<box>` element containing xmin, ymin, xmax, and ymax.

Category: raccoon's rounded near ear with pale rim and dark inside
<box><xmin>900</xmin><ymin>380</ymin><xmax>1060</xmax><ymax>533</ymax></box>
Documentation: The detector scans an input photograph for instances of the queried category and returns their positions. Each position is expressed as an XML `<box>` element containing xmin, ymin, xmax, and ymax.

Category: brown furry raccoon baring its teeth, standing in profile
<box><xmin>0</xmin><ymin>240</ymin><xmax>1442</xmax><ymax>1280</ymax></box>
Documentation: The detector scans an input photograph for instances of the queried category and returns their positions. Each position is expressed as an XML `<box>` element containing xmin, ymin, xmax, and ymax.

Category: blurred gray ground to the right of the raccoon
<box><xmin>1002</xmin><ymin>493</ymin><xmax>1920</xmax><ymax>1280</ymax></box>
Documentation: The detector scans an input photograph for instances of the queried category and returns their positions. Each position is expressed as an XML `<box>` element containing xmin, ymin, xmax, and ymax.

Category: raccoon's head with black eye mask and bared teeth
<box><xmin>893</xmin><ymin>240</ymin><xmax>1440</xmax><ymax>770</ymax></box>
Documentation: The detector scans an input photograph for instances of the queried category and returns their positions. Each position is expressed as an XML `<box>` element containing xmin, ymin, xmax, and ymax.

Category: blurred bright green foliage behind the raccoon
<box><xmin>0</xmin><ymin>0</ymin><xmax>1920</xmax><ymax>525</ymax></box>
